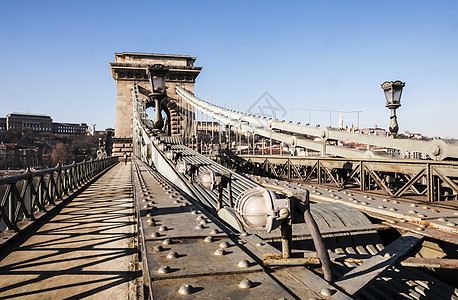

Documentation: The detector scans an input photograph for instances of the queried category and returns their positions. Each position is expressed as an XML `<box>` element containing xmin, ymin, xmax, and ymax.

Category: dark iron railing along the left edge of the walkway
<box><xmin>0</xmin><ymin>157</ymin><xmax>118</xmax><ymax>232</ymax></box>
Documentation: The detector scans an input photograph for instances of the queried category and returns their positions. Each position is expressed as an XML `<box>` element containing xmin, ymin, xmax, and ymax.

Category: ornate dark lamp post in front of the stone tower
<box><xmin>146</xmin><ymin>64</ymin><xmax>169</xmax><ymax>129</ymax></box>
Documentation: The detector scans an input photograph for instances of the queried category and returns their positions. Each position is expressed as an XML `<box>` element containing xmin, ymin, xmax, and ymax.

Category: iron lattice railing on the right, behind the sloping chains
<box><xmin>215</xmin><ymin>154</ymin><xmax>458</xmax><ymax>202</ymax></box>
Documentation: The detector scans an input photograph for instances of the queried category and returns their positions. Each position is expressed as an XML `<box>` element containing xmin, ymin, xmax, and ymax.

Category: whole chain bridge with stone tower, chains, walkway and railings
<box><xmin>0</xmin><ymin>52</ymin><xmax>458</xmax><ymax>299</ymax></box>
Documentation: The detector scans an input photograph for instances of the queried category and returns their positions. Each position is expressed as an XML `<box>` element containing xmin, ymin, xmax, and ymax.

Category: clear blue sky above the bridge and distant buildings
<box><xmin>0</xmin><ymin>0</ymin><xmax>458</xmax><ymax>138</ymax></box>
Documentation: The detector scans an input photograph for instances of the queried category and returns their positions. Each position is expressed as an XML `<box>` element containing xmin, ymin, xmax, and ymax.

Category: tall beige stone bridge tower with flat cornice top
<box><xmin>110</xmin><ymin>52</ymin><xmax>202</xmax><ymax>156</ymax></box>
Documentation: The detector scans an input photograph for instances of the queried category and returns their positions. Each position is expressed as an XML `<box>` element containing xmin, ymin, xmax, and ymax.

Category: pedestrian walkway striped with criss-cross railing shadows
<box><xmin>0</xmin><ymin>163</ymin><xmax>138</xmax><ymax>300</ymax></box>
